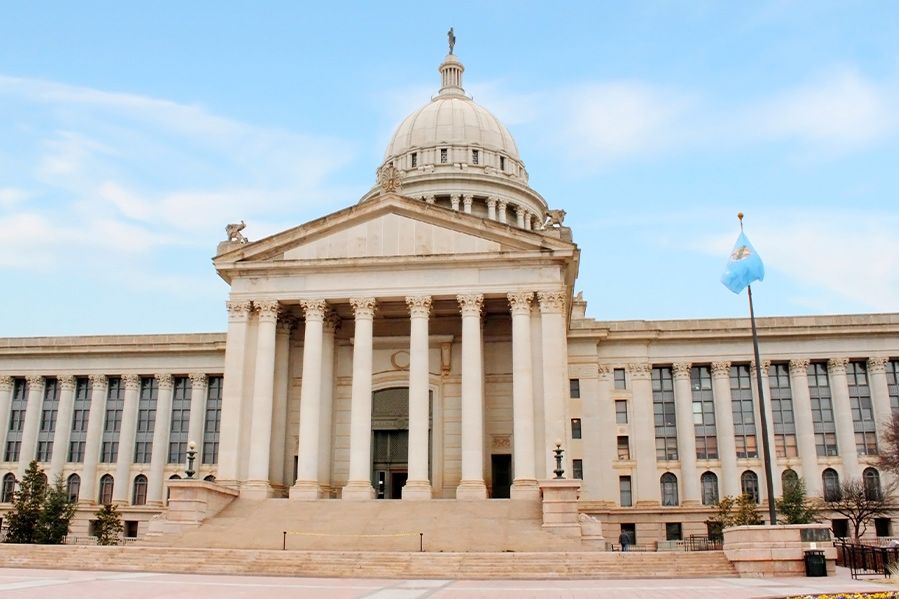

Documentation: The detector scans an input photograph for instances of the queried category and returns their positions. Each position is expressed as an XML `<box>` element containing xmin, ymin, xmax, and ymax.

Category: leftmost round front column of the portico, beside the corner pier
<box><xmin>240</xmin><ymin>300</ymin><xmax>278</xmax><ymax>498</ymax></box>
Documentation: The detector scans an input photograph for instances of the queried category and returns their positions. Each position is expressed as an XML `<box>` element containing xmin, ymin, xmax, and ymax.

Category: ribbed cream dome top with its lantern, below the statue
<box><xmin>384</xmin><ymin>54</ymin><xmax>521</xmax><ymax>160</ymax></box>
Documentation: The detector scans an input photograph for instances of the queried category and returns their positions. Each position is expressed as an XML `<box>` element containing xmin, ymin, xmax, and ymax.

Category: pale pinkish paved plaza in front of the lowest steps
<box><xmin>0</xmin><ymin>568</ymin><xmax>896</xmax><ymax>599</ymax></box>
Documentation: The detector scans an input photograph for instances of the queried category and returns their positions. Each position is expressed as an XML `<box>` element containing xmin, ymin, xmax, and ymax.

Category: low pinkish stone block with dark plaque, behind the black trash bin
<box><xmin>724</xmin><ymin>524</ymin><xmax>837</xmax><ymax>577</ymax></box>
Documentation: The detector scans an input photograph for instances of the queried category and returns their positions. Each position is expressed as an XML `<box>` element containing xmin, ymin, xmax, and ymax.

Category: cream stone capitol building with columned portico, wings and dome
<box><xmin>0</xmin><ymin>45</ymin><xmax>899</xmax><ymax>544</ymax></box>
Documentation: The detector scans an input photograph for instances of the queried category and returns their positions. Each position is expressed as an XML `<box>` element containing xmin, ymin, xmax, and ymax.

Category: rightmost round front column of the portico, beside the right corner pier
<box><xmin>507</xmin><ymin>291</ymin><xmax>546</xmax><ymax>499</ymax></box>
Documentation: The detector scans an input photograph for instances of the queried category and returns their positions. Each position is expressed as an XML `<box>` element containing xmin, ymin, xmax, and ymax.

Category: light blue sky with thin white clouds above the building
<box><xmin>0</xmin><ymin>0</ymin><xmax>899</xmax><ymax>336</ymax></box>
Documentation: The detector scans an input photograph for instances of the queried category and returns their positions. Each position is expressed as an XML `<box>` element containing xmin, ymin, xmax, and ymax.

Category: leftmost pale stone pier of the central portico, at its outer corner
<box><xmin>216</xmin><ymin>301</ymin><xmax>252</xmax><ymax>487</ymax></box>
